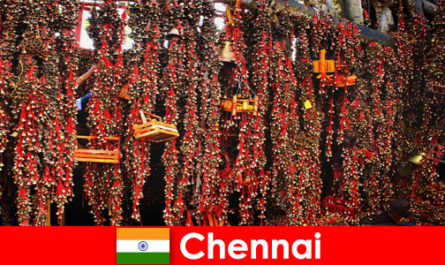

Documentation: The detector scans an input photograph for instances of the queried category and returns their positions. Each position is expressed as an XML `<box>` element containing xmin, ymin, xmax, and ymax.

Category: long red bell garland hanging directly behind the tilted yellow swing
<box><xmin>123</xmin><ymin>1</ymin><xmax>161</xmax><ymax>221</ymax></box>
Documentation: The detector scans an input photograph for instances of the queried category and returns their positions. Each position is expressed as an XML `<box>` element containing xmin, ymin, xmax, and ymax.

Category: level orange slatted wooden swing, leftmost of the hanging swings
<box><xmin>74</xmin><ymin>136</ymin><xmax>121</xmax><ymax>164</ymax></box>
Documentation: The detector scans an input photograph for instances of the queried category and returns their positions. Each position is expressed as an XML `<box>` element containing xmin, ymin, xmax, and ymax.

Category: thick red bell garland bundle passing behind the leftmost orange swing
<box><xmin>84</xmin><ymin>1</ymin><xmax>126</xmax><ymax>225</ymax></box>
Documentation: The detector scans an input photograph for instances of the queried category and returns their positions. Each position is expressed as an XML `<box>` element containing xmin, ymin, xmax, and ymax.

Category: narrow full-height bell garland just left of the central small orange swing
<box><xmin>193</xmin><ymin>0</ymin><xmax>222</xmax><ymax>225</ymax></box>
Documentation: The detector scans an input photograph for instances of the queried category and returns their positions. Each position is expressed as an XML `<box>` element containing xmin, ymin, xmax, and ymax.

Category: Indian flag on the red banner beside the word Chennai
<box><xmin>116</xmin><ymin>228</ymin><xmax>170</xmax><ymax>264</ymax></box>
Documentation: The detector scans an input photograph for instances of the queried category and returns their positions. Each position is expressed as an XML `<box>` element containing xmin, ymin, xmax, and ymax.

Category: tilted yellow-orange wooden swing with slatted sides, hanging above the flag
<box><xmin>133</xmin><ymin>110</ymin><xmax>179</xmax><ymax>143</ymax></box>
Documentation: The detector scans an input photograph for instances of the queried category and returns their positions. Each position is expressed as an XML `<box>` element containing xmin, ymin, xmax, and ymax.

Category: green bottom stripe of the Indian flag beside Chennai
<box><xmin>116</xmin><ymin>252</ymin><xmax>170</xmax><ymax>264</ymax></box>
